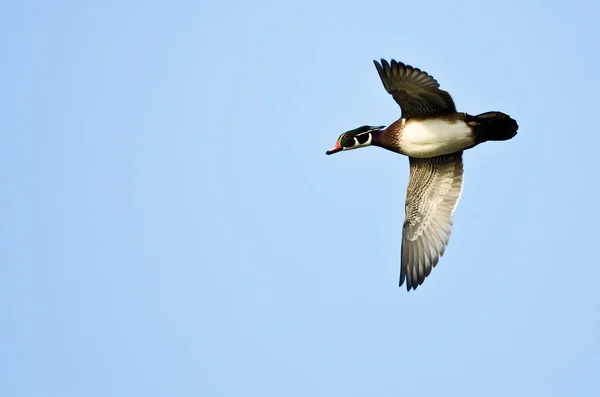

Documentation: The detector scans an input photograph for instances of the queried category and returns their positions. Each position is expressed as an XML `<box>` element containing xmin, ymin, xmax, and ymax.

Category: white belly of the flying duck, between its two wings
<box><xmin>397</xmin><ymin>119</ymin><xmax>475</xmax><ymax>158</ymax></box>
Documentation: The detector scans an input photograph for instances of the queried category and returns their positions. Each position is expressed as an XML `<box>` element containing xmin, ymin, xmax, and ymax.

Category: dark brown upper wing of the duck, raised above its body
<box><xmin>373</xmin><ymin>59</ymin><xmax>456</xmax><ymax>118</ymax></box>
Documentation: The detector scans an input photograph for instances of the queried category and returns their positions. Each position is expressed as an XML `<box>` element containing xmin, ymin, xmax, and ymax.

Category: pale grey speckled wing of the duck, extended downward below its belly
<box><xmin>400</xmin><ymin>152</ymin><xmax>463</xmax><ymax>291</ymax></box>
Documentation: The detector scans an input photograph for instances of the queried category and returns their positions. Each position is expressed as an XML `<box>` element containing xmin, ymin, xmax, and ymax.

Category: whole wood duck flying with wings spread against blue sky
<box><xmin>326</xmin><ymin>59</ymin><xmax>519</xmax><ymax>291</ymax></box>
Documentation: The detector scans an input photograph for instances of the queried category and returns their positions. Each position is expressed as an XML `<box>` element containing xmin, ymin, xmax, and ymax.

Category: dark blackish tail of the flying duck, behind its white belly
<box><xmin>465</xmin><ymin>112</ymin><xmax>519</xmax><ymax>143</ymax></box>
